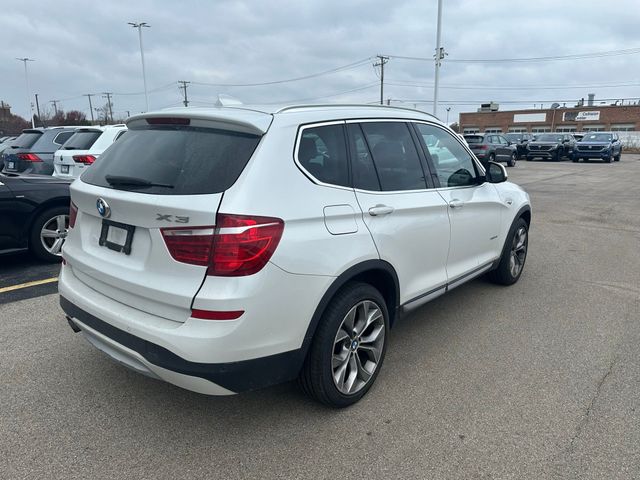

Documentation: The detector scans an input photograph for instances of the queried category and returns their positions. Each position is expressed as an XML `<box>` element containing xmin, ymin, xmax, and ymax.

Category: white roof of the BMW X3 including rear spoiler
<box><xmin>127</xmin><ymin>104</ymin><xmax>444</xmax><ymax>134</ymax></box>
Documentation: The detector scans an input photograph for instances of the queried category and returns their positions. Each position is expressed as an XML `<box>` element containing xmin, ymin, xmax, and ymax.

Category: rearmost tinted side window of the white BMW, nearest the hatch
<box><xmin>298</xmin><ymin>124</ymin><xmax>350</xmax><ymax>187</ymax></box>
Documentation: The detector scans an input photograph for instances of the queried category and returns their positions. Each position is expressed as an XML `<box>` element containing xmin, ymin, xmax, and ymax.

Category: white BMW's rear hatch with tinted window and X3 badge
<box><xmin>65</xmin><ymin>114</ymin><xmax>271</xmax><ymax>322</ymax></box>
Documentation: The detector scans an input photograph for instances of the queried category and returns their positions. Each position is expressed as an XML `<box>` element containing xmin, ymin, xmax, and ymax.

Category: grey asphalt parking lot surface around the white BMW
<box><xmin>0</xmin><ymin>154</ymin><xmax>640</xmax><ymax>479</ymax></box>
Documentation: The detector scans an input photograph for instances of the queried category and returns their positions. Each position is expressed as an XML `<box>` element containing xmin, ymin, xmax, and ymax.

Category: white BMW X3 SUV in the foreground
<box><xmin>59</xmin><ymin>105</ymin><xmax>531</xmax><ymax>407</ymax></box>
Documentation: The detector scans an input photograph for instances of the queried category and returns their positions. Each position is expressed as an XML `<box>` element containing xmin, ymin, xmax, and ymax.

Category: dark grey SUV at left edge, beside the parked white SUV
<box><xmin>1</xmin><ymin>127</ymin><xmax>78</xmax><ymax>175</ymax></box>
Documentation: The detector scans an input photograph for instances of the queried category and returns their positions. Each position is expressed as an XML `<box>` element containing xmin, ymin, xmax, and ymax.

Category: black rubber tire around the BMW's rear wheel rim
<box><xmin>298</xmin><ymin>282</ymin><xmax>389</xmax><ymax>408</ymax></box>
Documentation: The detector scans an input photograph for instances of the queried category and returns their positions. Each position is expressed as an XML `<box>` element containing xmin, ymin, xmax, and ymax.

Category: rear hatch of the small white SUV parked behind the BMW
<box><xmin>53</xmin><ymin>128</ymin><xmax>103</xmax><ymax>178</ymax></box>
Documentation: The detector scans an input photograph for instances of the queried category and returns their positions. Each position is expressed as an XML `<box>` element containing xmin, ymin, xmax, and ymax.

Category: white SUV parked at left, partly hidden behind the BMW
<box><xmin>53</xmin><ymin>124</ymin><xmax>127</xmax><ymax>179</ymax></box>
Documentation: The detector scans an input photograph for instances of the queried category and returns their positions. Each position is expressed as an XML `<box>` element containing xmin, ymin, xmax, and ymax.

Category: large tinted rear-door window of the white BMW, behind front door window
<box><xmin>361</xmin><ymin>122</ymin><xmax>427</xmax><ymax>191</ymax></box>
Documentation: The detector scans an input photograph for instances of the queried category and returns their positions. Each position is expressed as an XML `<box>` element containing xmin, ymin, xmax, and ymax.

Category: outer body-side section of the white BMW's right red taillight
<box><xmin>207</xmin><ymin>213</ymin><xmax>284</xmax><ymax>277</ymax></box>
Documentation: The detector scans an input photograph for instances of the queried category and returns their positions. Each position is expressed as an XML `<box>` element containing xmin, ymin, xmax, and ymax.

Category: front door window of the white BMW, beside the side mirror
<box><xmin>416</xmin><ymin>123</ymin><xmax>478</xmax><ymax>187</ymax></box>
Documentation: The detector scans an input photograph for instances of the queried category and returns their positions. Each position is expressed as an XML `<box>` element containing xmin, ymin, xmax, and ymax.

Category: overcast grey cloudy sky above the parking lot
<box><xmin>0</xmin><ymin>0</ymin><xmax>640</xmax><ymax>123</ymax></box>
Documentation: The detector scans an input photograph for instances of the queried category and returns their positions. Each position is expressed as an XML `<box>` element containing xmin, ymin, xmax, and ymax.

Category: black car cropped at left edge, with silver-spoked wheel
<box><xmin>0</xmin><ymin>173</ymin><xmax>70</xmax><ymax>262</ymax></box>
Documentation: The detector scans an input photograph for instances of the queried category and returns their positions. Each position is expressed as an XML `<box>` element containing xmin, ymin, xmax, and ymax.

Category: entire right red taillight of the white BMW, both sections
<box><xmin>161</xmin><ymin>213</ymin><xmax>284</xmax><ymax>277</ymax></box>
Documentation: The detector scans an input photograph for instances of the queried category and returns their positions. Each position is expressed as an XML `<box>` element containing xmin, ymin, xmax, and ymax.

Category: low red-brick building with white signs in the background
<box><xmin>460</xmin><ymin>104</ymin><xmax>640</xmax><ymax>133</ymax></box>
